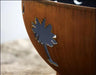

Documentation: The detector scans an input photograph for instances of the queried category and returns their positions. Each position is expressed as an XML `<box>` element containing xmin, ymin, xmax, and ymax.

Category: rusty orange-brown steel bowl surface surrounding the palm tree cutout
<box><xmin>22</xmin><ymin>0</ymin><xmax>96</xmax><ymax>75</ymax></box>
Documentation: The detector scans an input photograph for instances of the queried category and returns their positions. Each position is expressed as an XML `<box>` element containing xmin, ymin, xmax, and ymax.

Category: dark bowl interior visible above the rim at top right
<box><xmin>51</xmin><ymin>0</ymin><xmax>96</xmax><ymax>7</ymax></box>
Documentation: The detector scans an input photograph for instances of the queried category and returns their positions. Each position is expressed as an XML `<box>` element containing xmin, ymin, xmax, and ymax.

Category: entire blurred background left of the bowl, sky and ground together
<box><xmin>0</xmin><ymin>0</ymin><xmax>55</xmax><ymax>75</ymax></box>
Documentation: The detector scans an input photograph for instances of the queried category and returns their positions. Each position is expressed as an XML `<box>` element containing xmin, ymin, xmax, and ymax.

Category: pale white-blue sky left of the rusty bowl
<box><xmin>1</xmin><ymin>0</ymin><xmax>28</xmax><ymax>43</ymax></box>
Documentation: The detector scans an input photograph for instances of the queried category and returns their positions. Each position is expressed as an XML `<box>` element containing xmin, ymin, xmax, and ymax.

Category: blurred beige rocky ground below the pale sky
<box><xmin>1</xmin><ymin>39</ymin><xmax>56</xmax><ymax>75</ymax></box>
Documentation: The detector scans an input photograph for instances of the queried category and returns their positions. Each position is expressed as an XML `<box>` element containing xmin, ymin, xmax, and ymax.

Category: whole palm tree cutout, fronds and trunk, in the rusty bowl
<box><xmin>32</xmin><ymin>18</ymin><xmax>58</xmax><ymax>66</ymax></box>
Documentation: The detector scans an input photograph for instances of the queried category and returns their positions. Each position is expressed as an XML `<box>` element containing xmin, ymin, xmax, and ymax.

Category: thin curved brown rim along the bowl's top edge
<box><xmin>22</xmin><ymin>0</ymin><xmax>96</xmax><ymax>10</ymax></box>
